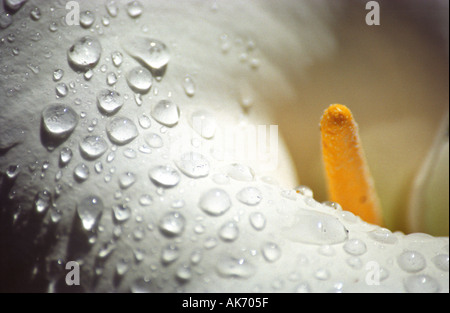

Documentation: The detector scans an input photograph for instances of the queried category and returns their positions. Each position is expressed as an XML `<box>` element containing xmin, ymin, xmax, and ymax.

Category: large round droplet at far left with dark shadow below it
<box><xmin>42</xmin><ymin>104</ymin><xmax>78</xmax><ymax>138</ymax></box>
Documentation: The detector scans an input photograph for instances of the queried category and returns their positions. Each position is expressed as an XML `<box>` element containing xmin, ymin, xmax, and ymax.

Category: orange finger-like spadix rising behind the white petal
<box><xmin>320</xmin><ymin>104</ymin><xmax>382</xmax><ymax>225</ymax></box>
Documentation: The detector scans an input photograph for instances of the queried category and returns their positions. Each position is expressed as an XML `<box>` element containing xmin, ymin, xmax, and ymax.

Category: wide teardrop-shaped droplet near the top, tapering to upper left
<box><xmin>122</xmin><ymin>36</ymin><xmax>170</xmax><ymax>76</ymax></box>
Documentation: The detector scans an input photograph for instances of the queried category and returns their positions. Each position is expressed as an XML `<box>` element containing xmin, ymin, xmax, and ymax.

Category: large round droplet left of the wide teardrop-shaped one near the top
<box><xmin>67</xmin><ymin>36</ymin><xmax>102</xmax><ymax>70</ymax></box>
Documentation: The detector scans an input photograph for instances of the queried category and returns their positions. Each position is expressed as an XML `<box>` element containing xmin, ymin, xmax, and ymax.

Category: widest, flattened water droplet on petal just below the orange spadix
<box><xmin>282</xmin><ymin>211</ymin><xmax>347</xmax><ymax>245</ymax></box>
